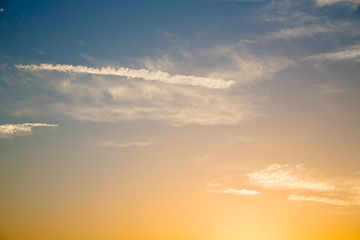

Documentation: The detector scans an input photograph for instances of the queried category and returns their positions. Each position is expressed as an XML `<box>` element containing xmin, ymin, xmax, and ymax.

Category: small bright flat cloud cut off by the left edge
<box><xmin>0</xmin><ymin>123</ymin><xmax>59</xmax><ymax>138</ymax></box>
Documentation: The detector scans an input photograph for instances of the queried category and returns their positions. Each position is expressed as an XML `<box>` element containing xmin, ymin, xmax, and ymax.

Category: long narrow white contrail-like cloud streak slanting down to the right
<box><xmin>15</xmin><ymin>64</ymin><xmax>234</xmax><ymax>88</ymax></box>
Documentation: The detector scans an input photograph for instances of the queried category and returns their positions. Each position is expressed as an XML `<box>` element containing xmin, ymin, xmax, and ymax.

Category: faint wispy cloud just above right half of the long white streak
<box><xmin>142</xmin><ymin>40</ymin><xmax>295</xmax><ymax>86</ymax></box>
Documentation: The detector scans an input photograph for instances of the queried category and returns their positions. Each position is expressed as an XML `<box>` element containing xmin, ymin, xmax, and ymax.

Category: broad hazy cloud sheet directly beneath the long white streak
<box><xmin>4</xmin><ymin>64</ymin><xmax>259</xmax><ymax>126</ymax></box>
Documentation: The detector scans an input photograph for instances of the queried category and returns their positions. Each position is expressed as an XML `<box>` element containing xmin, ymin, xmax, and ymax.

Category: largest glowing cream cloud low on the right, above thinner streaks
<box><xmin>246</xmin><ymin>164</ymin><xmax>335</xmax><ymax>191</ymax></box>
